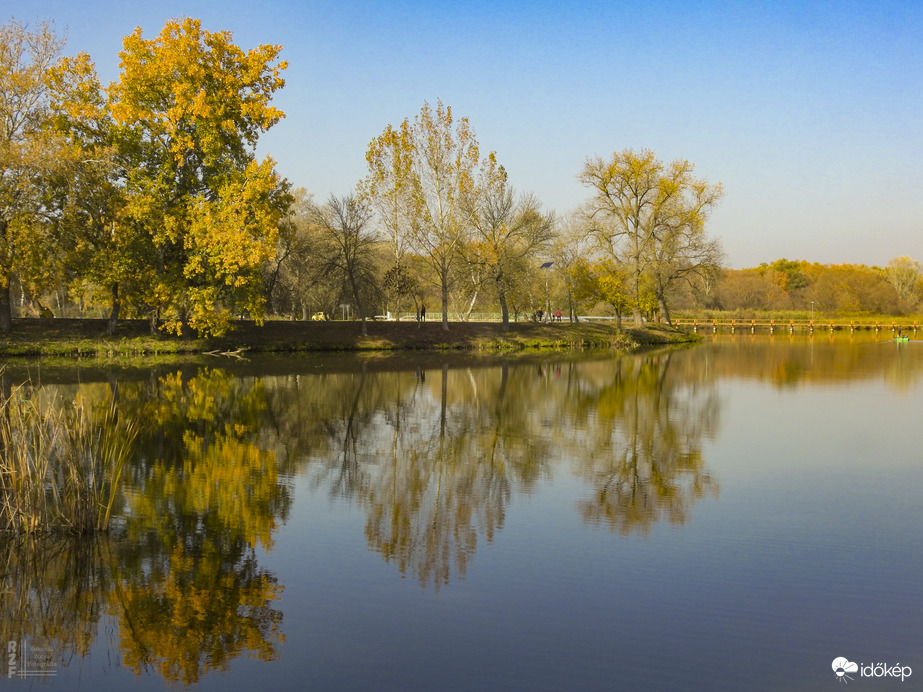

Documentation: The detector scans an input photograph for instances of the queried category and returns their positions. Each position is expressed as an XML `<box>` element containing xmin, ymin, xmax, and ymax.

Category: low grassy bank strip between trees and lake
<box><xmin>0</xmin><ymin>319</ymin><xmax>695</xmax><ymax>358</ymax></box>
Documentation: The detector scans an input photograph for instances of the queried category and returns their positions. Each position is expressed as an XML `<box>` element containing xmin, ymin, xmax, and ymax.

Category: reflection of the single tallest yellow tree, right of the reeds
<box><xmin>117</xmin><ymin>369</ymin><xmax>291</xmax><ymax>683</ymax></box>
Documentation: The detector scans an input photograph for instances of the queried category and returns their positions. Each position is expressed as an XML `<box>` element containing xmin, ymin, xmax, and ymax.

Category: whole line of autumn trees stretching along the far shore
<box><xmin>0</xmin><ymin>18</ymin><xmax>923</xmax><ymax>335</ymax></box>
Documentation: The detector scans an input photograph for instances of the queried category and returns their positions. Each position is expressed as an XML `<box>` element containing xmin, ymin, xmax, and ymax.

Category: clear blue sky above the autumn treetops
<box><xmin>16</xmin><ymin>0</ymin><xmax>923</xmax><ymax>268</ymax></box>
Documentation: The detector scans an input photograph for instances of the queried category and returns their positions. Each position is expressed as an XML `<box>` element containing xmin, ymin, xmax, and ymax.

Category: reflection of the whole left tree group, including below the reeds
<box><xmin>0</xmin><ymin>370</ymin><xmax>291</xmax><ymax>684</ymax></box>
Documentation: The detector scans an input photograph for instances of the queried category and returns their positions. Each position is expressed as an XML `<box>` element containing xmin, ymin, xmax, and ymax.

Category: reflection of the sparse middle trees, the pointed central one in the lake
<box><xmin>266</xmin><ymin>365</ymin><xmax>552</xmax><ymax>588</ymax></box>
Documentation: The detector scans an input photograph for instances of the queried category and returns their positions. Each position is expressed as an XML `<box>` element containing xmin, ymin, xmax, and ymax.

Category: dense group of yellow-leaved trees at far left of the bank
<box><xmin>0</xmin><ymin>18</ymin><xmax>291</xmax><ymax>334</ymax></box>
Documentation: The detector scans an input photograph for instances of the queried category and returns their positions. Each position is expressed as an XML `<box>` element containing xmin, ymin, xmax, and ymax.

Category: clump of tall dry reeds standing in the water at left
<box><xmin>0</xmin><ymin>386</ymin><xmax>138</xmax><ymax>533</ymax></box>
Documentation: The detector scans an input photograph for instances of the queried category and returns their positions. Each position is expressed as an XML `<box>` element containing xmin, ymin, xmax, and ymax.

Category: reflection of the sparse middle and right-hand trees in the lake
<box><xmin>267</xmin><ymin>353</ymin><xmax>718</xmax><ymax>589</ymax></box>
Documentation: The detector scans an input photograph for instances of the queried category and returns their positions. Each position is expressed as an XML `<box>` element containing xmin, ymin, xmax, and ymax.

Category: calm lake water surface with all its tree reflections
<box><xmin>0</xmin><ymin>334</ymin><xmax>923</xmax><ymax>692</ymax></box>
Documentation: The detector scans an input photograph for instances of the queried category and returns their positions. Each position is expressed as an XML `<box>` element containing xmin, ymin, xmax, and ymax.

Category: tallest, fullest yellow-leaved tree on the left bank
<box><xmin>108</xmin><ymin>18</ymin><xmax>291</xmax><ymax>334</ymax></box>
